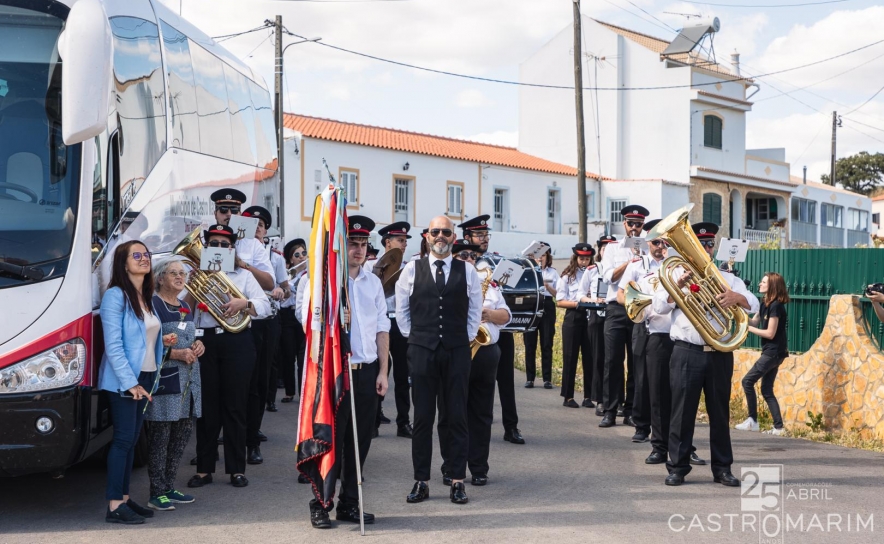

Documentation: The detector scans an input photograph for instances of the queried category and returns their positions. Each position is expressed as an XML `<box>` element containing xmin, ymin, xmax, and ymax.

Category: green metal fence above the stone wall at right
<box><xmin>735</xmin><ymin>248</ymin><xmax>884</xmax><ymax>353</ymax></box>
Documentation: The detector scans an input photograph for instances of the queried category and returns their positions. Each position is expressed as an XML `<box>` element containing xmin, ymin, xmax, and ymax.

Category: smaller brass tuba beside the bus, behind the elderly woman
<box><xmin>172</xmin><ymin>227</ymin><xmax>251</xmax><ymax>332</ymax></box>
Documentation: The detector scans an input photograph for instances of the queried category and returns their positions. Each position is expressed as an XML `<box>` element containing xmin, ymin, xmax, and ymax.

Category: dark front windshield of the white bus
<box><xmin>0</xmin><ymin>5</ymin><xmax>81</xmax><ymax>288</ymax></box>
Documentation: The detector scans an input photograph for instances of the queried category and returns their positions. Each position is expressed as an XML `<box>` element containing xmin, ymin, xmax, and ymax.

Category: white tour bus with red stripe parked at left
<box><xmin>0</xmin><ymin>0</ymin><xmax>278</xmax><ymax>476</ymax></box>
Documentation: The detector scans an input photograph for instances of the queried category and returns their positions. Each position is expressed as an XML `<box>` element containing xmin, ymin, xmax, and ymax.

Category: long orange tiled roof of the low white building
<box><xmin>284</xmin><ymin>113</ymin><xmax>598</xmax><ymax>178</ymax></box>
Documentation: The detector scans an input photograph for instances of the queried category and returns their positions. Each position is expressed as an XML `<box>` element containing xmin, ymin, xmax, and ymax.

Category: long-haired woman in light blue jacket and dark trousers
<box><xmin>98</xmin><ymin>240</ymin><xmax>176</xmax><ymax>525</ymax></box>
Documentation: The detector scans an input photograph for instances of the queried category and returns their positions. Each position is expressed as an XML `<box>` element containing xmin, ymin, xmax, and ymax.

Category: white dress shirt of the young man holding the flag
<box><xmin>347</xmin><ymin>267</ymin><xmax>390</xmax><ymax>365</ymax></box>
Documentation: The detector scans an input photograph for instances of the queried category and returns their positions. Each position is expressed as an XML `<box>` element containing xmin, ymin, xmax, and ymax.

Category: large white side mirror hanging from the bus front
<box><xmin>58</xmin><ymin>0</ymin><xmax>113</xmax><ymax>145</ymax></box>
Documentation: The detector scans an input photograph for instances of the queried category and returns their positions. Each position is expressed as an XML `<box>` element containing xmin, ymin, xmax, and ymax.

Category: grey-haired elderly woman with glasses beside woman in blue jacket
<box><xmin>145</xmin><ymin>258</ymin><xmax>205</xmax><ymax>510</ymax></box>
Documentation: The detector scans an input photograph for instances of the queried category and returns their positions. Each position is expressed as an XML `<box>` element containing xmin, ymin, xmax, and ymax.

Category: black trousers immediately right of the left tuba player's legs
<box><xmin>247</xmin><ymin>317</ymin><xmax>280</xmax><ymax>448</ymax></box>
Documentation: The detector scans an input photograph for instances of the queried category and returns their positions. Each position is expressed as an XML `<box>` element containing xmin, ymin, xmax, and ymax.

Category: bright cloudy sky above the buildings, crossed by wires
<box><xmin>161</xmin><ymin>0</ymin><xmax>884</xmax><ymax>183</ymax></box>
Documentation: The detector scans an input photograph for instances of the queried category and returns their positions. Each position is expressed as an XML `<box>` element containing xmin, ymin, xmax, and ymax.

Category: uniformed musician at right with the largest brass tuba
<box><xmin>650</xmin><ymin>221</ymin><xmax>759</xmax><ymax>487</ymax></box>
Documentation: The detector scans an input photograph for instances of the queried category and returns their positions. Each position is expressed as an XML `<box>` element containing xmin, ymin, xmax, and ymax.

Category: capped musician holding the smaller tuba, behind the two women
<box><xmin>186</xmin><ymin>225</ymin><xmax>270</xmax><ymax>487</ymax></box>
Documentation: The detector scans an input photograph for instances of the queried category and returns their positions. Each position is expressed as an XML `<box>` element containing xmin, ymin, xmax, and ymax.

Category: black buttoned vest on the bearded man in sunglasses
<box><xmin>408</xmin><ymin>257</ymin><xmax>470</xmax><ymax>349</ymax></box>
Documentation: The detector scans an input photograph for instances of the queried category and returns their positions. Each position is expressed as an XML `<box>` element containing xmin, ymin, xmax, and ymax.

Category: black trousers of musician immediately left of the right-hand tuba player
<box><xmin>633</xmin><ymin>332</ymin><xmax>674</xmax><ymax>457</ymax></box>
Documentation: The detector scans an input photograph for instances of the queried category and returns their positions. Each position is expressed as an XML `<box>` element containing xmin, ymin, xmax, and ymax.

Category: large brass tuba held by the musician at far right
<box><xmin>647</xmin><ymin>204</ymin><xmax>749</xmax><ymax>352</ymax></box>
